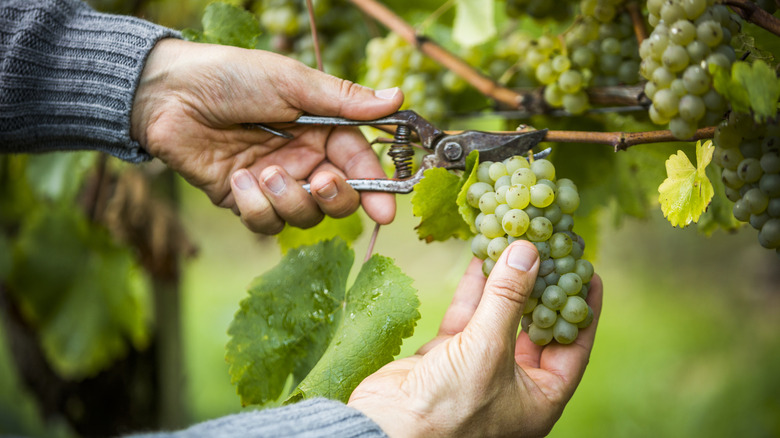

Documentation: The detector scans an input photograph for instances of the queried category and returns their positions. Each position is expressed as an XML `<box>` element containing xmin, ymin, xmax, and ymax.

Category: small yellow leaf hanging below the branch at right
<box><xmin>658</xmin><ymin>140</ymin><xmax>715</xmax><ymax>227</ymax></box>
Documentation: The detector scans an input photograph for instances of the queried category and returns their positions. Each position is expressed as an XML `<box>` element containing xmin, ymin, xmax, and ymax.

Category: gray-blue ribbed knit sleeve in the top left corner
<box><xmin>0</xmin><ymin>0</ymin><xmax>178</xmax><ymax>162</ymax></box>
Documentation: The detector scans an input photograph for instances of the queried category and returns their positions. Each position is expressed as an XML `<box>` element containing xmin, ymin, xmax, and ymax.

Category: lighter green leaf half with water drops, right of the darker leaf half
<box><xmin>288</xmin><ymin>255</ymin><xmax>420</xmax><ymax>403</ymax></box>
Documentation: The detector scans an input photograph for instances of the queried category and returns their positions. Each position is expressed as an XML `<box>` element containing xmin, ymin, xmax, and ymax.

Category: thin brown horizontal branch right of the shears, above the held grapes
<box><xmin>544</xmin><ymin>126</ymin><xmax>715</xmax><ymax>152</ymax></box>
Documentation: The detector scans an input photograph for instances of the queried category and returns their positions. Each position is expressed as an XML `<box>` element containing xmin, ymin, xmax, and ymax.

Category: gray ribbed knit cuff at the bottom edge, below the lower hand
<box><xmin>127</xmin><ymin>398</ymin><xmax>387</xmax><ymax>438</ymax></box>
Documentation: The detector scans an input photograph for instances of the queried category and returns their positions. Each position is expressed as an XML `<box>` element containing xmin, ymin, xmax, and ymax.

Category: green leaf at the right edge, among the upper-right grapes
<box><xmin>710</xmin><ymin>60</ymin><xmax>780</xmax><ymax>122</ymax></box>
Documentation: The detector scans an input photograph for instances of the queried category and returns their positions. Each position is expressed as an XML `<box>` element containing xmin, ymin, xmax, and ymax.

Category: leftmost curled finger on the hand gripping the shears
<box><xmin>230</xmin><ymin>169</ymin><xmax>284</xmax><ymax>234</ymax></box>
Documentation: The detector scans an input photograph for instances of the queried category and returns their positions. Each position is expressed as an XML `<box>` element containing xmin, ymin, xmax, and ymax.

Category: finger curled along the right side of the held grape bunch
<box><xmin>539</xmin><ymin>275</ymin><xmax>603</xmax><ymax>396</ymax></box>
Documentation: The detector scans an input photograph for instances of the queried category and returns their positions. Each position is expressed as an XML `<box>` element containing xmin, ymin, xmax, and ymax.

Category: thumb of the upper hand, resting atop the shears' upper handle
<box><xmin>290</xmin><ymin>63</ymin><xmax>404</xmax><ymax>120</ymax></box>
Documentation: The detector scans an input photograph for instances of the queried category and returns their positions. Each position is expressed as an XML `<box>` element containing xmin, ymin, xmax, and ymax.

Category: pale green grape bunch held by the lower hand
<box><xmin>466</xmin><ymin>156</ymin><xmax>593</xmax><ymax>345</ymax></box>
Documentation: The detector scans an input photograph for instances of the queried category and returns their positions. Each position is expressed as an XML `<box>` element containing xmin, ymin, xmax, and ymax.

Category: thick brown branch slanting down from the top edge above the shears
<box><xmin>351</xmin><ymin>0</ymin><xmax>524</xmax><ymax>109</ymax></box>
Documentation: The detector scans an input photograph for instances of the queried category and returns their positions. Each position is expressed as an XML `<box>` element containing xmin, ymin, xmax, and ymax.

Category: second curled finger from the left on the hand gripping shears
<box><xmin>259</xmin><ymin>166</ymin><xmax>323</xmax><ymax>228</ymax></box>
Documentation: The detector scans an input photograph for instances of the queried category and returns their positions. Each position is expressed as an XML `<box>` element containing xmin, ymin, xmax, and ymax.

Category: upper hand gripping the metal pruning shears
<box><xmin>131</xmin><ymin>39</ymin><xmax>403</xmax><ymax>234</ymax></box>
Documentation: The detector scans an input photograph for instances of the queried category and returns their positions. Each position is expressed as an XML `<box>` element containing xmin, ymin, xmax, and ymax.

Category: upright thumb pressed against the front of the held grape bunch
<box><xmin>469</xmin><ymin>240</ymin><xmax>539</xmax><ymax>345</ymax></box>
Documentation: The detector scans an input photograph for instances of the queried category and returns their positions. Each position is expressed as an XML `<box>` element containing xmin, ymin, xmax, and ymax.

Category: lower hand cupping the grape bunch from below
<box><xmin>349</xmin><ymin>241</ymin><xmax>602</xmax><ymax>437</ymax></box>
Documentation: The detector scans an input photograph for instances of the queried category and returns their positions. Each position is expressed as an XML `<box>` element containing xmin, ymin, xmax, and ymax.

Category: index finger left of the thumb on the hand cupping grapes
<box><xmin>417</xmin><ymin>257</ymin><xmax>485</xmax><ymax>354</ymax></box>
